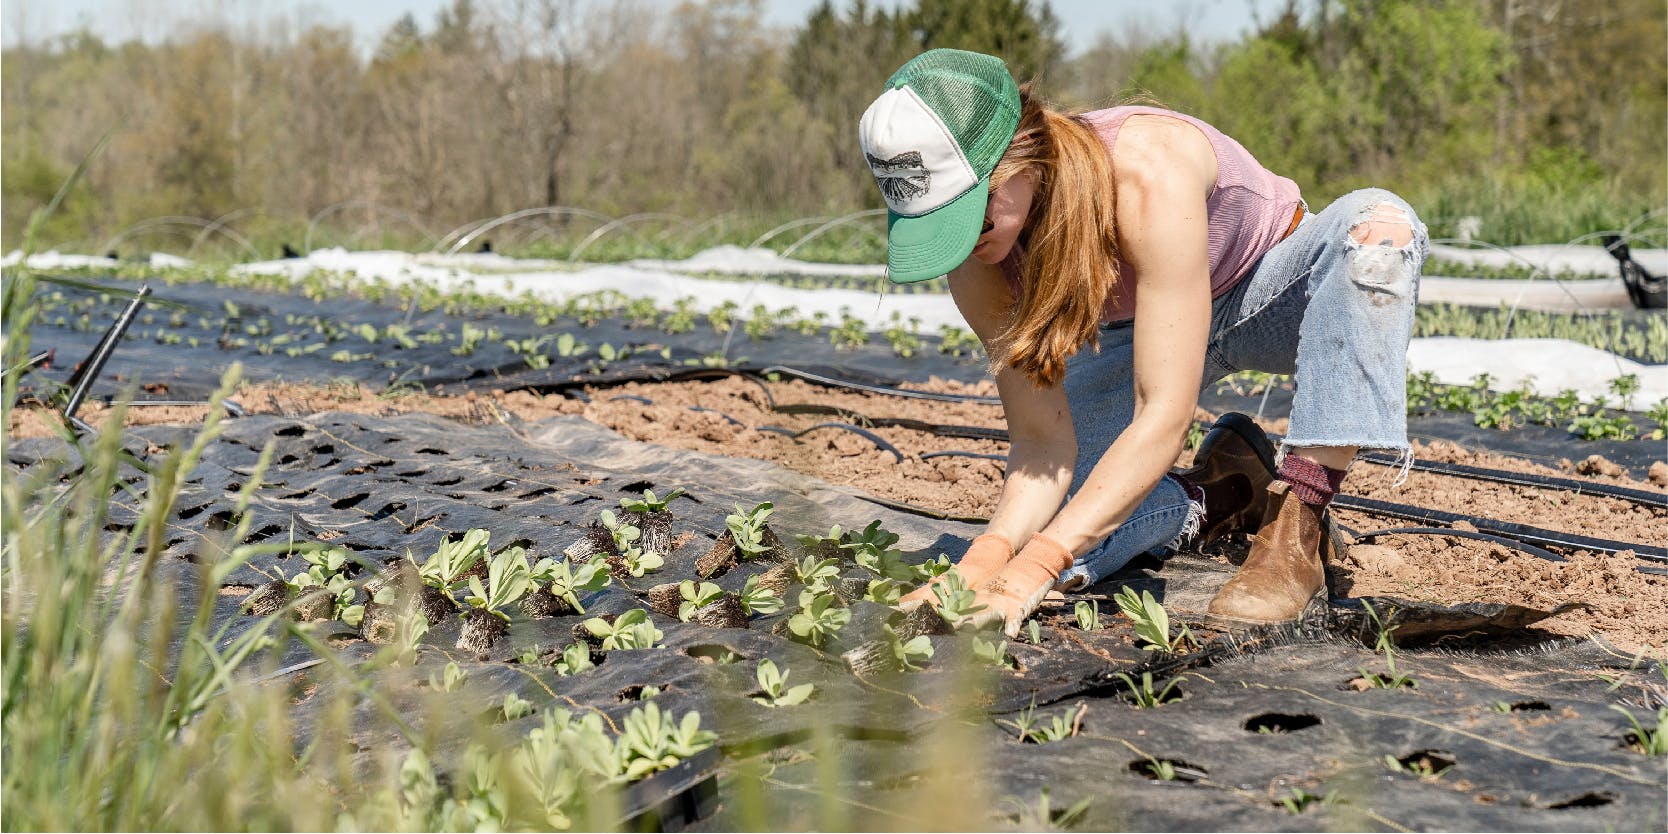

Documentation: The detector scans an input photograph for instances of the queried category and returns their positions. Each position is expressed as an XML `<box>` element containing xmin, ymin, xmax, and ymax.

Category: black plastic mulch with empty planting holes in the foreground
<box><xmin>7</xmin><ymin>414</ymin><xmax>1665</xmax><ymax>831</ymax></box>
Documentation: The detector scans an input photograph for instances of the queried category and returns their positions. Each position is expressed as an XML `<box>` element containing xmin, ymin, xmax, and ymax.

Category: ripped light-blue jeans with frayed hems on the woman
<box><xmin>1059</xmin><ymin>188</ymin><xmax>1429</xmax><ymax>590</ymax></box>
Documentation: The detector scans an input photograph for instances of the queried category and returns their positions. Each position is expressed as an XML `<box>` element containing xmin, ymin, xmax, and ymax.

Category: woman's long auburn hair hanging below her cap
<box><xmin>991</xmin><ymin>83</ymin><xmax>1119</xmax><ymax>387</ymax></box>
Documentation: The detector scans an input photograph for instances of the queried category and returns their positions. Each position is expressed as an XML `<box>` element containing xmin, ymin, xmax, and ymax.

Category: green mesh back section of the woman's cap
<box><xmin>886</xmin><ymin>48</ymin><xmax>1019</xmax><ymax>178</ymax></box>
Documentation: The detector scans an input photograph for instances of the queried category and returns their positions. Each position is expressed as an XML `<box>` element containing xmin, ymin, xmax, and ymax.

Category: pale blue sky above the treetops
<box><xmin>0</xmin><ymin>0</ymin><xmax>1284</xmax><ymax>52</ymax></box>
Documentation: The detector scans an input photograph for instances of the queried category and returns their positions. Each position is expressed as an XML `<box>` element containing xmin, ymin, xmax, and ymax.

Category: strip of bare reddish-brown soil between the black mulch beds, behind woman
<box><xmin>7</xmin><ymin>377</ymin><xmax>1668</xmax><ymax>657</ymax></box>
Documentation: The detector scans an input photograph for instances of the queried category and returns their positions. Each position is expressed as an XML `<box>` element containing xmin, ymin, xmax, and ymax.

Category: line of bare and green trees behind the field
<box><xmin>0</xmin><ymin>0</ymin><xmax>1668</xmax><ymax>249</ymax></box>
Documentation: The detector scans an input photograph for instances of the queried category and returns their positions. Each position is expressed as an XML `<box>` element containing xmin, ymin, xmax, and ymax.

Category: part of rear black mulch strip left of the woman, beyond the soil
<box><xmin>19</xmin><ymin>273</ymin><xmax>984</xmax><ymax>399</ymax></box>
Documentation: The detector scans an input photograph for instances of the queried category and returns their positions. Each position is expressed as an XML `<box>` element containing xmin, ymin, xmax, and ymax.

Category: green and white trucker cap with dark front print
<box><xmin>857</xmin><ymin>48</ymin><xmax>1019</xmax><ymax>284</ymax></box>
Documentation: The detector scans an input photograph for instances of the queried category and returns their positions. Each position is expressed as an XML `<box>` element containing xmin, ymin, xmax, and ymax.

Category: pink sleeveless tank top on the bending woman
<box><xmin>1002</xmin><ymin>107</ymin><xmax>1301</xmax><ymax>324</ymax></box>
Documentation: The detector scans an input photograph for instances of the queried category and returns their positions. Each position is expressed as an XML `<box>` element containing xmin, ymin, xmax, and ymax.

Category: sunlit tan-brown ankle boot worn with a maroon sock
<box><xmin>1206</xmin><ymin>480</ymin><xmax>1333</xmax><ymax>629</ymax></box>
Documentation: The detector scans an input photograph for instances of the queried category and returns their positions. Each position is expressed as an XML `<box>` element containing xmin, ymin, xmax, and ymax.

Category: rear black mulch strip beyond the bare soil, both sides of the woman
<box><xmin>25</xmin><ymin>280</ymin><xmax>1668</xmax><ymax>477</ymax></box>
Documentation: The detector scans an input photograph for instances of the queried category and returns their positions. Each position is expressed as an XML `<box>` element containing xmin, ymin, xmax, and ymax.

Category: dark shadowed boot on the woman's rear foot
<box><xmin>1176</xmin><ymin>412</ymin><xmax>1274</xmax><ymax>547</ymax></box>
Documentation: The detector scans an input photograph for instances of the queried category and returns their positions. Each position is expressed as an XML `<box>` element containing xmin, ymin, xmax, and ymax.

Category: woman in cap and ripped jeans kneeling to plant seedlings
<box><xmin>859</xmin><ymin>50</ymin><xmax>1426</xmax><ymax>634</ymax></box>
